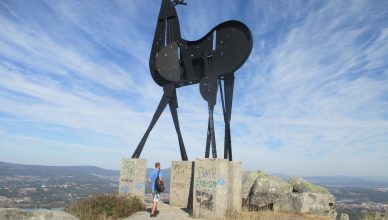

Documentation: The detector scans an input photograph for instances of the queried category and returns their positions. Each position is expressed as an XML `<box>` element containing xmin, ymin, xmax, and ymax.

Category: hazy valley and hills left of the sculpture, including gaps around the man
<box><xmin>0</xmin><ymin>162</ymin><xmax>171</xmax><ymax>208</ymax></box>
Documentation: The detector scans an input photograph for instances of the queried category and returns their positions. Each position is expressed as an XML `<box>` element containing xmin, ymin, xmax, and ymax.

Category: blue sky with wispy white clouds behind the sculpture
<box><xmin>0</xmin><ymin>0</ymin><xmax>388</xmax><ymax>176</ymax></box>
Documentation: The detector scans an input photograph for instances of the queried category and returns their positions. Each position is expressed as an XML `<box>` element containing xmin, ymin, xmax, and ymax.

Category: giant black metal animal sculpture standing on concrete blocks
<box><xmin>132</xmin><ymin>0</ymin><xmax>253</xmax><ymax>161</ymax></box>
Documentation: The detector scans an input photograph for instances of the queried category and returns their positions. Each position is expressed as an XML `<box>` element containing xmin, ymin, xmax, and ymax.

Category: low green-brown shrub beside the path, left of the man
<box><xmin>65</xmin><ymin>195</ymin><xmax>146</xmax><ymax>220</ymax></box>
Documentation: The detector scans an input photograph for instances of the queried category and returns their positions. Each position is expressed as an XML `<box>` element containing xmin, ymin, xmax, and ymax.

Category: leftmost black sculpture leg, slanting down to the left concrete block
<box><xmin>132</xmin><ymin>84</ymin><xmax>171</xmax><ymax>158</ymax></box>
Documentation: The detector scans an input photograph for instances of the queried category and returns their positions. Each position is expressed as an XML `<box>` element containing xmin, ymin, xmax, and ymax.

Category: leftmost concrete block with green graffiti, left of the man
<box><xmin>119</xmin><ymin>158</ymin><xmax>146</xmax><ymax>199</ymax></box>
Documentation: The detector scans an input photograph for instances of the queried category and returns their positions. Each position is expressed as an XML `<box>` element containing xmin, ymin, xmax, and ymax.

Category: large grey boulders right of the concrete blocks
<box><xmin>242</xmin><ymin>171</ymin><xmax>336</xmax><ymax>217</ymax></box>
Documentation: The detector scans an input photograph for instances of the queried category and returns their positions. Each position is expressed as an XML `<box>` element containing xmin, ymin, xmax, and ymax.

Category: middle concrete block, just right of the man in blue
<box><xmin>170</xmin><ymin>161</ymin><xmax>194</xmax><ymax>208</ymax></box>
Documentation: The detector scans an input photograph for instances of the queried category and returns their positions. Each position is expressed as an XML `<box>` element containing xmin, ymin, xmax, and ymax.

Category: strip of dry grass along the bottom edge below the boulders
<box><xmin>223</xmin><ymin>211</ymin><xmax>332</xmax><ymax>220</ymax></box>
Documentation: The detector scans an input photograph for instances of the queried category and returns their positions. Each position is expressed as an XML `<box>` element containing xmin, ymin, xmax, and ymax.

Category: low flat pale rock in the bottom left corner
<box><xmin>0</xmin><ymin>208</ymin><xmax>78</xmax><ymax>220</ymax></box>
